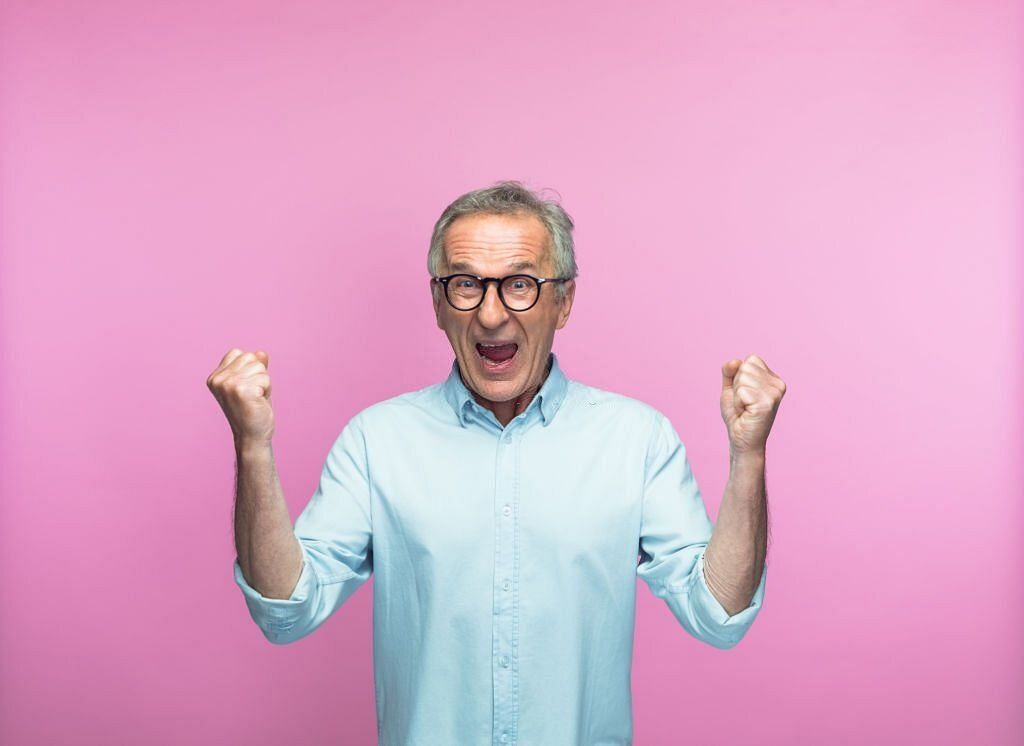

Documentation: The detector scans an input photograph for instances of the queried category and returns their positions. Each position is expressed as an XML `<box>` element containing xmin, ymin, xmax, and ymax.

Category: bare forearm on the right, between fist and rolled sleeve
<box><xmin>705</xmin><ymin>451</ymin><xmax>768</xmax><ymax>616</ymax></box>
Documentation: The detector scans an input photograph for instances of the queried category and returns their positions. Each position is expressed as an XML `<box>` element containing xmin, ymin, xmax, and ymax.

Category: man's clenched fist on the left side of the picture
<box><xmin>206</xmin><ymin>347</ymin><xmax>273</xmax><ymax>445</ymax></box>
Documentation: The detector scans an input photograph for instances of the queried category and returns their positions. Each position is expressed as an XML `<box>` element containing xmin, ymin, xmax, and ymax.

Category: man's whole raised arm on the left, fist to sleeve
<box><xmin>207</xmin><ymin>349</ymin><xmax>373</xmax><ymax>645</ymax></box>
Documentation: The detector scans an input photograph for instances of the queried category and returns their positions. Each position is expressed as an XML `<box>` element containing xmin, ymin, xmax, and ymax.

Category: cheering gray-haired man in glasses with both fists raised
<box><xmin>208</xmin><ymin>182</ymin><xmax>785</xmax><ymax>746</ymax></box>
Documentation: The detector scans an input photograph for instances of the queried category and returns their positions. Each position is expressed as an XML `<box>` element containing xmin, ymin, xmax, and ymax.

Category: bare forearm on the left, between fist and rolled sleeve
<box><xmin>234</xmin><ymin>443</ymin><xmax>302</xmax><ymax>599</ymax></box>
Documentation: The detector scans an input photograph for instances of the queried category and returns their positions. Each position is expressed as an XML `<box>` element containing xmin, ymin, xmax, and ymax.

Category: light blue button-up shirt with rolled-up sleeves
<box><xmin>234</xmin><ymin>353</ymin><xmax>767</xmax><ymax>746</ymax></box>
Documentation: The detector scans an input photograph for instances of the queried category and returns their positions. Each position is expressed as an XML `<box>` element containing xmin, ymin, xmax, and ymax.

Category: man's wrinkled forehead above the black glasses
<box><xmin>443</xmin><ymin>213</ymin><xmax>551</xmax><ymax>274</ymax></box>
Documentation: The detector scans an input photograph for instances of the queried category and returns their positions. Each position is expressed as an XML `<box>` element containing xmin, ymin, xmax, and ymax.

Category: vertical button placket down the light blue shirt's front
<box><xmin>492</xmin><ymin>428</ymin><xmax>518</xmax><ymax>744</ymax></box>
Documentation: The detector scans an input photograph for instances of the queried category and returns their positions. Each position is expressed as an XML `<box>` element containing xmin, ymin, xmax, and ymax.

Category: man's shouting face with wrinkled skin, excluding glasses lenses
<box><xmin>432</xmin><ymin>209</ymin><xmax>575</xmax><ymax>401</ymax></box>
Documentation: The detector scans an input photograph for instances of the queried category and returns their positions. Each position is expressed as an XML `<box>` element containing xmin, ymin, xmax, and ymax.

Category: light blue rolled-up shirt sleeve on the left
<box><xmin>233</xmin><ymin>416</ymin><xmax>373</xmax><ymax>645</ymax></box>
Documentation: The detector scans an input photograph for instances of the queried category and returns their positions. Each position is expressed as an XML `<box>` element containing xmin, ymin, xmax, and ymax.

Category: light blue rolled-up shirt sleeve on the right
<box><xmin>637</xmin><ymin>412</ymin><xmax>768</xmax><ymax>650</ymax></box>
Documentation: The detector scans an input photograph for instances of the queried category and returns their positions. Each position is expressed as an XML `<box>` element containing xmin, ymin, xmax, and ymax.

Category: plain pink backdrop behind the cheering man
<box><xmin>0</xmin><ymin>0</ymin><xmax>1024</xmax><ymax>745</ymax></box>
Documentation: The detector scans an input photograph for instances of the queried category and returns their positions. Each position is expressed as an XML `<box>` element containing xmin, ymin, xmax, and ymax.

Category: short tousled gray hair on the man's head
<box><xmin>427</xmin><ymin>181</ymin><xmax>580</xmax><ymax>301</ymax></box>
